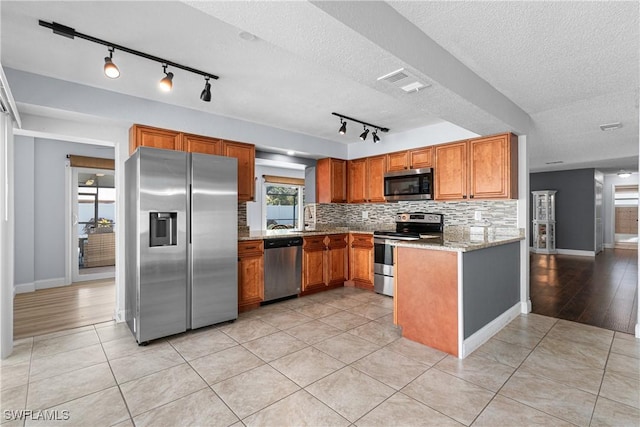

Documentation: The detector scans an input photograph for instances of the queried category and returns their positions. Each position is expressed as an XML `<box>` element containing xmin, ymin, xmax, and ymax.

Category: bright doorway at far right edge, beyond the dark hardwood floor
<box><xmin>613</xmin><ymin>185</ymin><xmax>638</xmax><ymax>249</ymax></box>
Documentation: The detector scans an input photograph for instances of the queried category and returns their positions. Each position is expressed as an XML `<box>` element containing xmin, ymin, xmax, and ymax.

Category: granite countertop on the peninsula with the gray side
<box><xmin>389</xmin><ymin>227</ymin><xmax>524</xmax><ymax>252</ymax></box>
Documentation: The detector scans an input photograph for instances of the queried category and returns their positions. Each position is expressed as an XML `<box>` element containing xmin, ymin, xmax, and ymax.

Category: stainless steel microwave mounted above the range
<box><xmin>384</xmin><ymin>168</ymin><xmax>433</xmax><ymax>202</ymax></box>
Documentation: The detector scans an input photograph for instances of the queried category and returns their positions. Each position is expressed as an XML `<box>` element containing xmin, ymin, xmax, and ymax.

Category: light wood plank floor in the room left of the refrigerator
<box><xmin>13</xmin><ymin>279</ymin><xmax>116</xmax><ymax>339</ymax></box>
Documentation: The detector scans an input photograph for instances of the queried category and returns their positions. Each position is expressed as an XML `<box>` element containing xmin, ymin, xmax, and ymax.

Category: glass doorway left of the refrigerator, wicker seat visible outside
<box><xmin>70</xmin><ymin>167</ymin><xmax>116</xmax><ymax>283</ymax></box>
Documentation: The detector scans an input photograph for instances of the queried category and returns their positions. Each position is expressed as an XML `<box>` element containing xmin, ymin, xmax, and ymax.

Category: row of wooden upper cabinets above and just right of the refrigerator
<box><xmin>129</xmin><ymin>125</ymin><xmax>256</xmax><ymax>202</ymax></box>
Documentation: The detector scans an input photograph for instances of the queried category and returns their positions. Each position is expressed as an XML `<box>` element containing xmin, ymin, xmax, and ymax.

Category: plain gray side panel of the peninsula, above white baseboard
<box><xmin>462</xmin><ymin>242</ymin><xmax>520</xmax><ymax>339</ymax></box>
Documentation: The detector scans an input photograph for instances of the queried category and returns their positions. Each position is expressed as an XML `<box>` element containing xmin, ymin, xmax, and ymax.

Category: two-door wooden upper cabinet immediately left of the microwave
<box><xmin>348</xmin><ymin>155</ymin><xmax>387</xmax><ymax>203</ymax></box>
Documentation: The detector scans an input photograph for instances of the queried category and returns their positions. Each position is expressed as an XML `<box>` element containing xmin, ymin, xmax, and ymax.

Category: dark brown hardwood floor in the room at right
<box><xmin>531</xmin><ymin>249</ymin><xmax>638</xmax><ymax>334</ymax></box>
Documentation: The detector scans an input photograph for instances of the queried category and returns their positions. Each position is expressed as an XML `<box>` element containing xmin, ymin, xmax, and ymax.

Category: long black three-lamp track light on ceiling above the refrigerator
<box><xmin>38</xmin><ymin>20</ymin><xmax>219</xmax><ymax>102</ymax></box>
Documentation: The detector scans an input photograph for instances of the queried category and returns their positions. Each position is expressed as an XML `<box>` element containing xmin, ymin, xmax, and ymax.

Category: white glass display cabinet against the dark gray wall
<box><xmin>531</xmin><ymin>190</ymin><xmax>556</xmax><ymax>254</ymax></box>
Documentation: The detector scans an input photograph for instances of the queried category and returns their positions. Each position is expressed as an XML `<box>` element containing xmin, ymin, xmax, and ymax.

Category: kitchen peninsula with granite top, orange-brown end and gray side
<box><xmin>392</xmin><ymin>232</ymin><xmax>523</xmax><ymax>358</ymax></box>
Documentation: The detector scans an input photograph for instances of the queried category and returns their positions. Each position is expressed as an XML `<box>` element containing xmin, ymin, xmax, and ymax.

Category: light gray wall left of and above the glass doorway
<box><xmin>15</xmin><ymin>136</ymin><xmax>114</xmax><ymax>285</ymax></box>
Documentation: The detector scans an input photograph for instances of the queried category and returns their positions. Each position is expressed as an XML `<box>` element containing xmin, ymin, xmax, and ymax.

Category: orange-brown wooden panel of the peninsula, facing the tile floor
<box><xmin>395</xmin><ymin>247</ymin><xmax>458</xmax><ymax>356</ymax></box>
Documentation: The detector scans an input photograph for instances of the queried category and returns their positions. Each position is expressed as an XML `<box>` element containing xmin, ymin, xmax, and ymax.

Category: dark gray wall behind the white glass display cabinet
<box><xmin>529</xmin><ymin>169</ymin><xmax>595</xmax><ymax>251</ymax></box>
